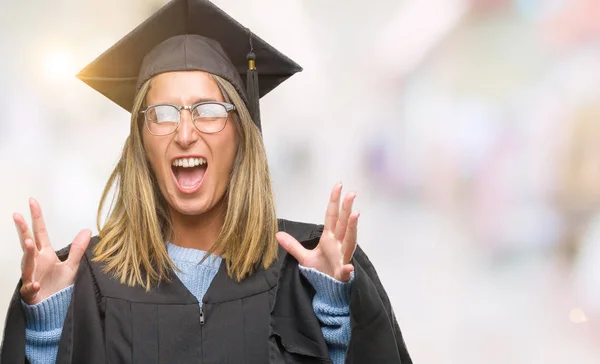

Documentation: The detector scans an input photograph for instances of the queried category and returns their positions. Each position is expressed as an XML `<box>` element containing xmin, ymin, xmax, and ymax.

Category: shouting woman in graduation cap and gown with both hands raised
<box><xmin>0</xmin><ymin>0</ymin><xmax>411</xmax><ymax>363</ymax></box>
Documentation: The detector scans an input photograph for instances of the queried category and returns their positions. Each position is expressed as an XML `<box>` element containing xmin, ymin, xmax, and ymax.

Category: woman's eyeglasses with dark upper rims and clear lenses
<box><xmin>140</xmin><ymin>101</ymin><xmax>235</xmax><ymax>135</ymax></box>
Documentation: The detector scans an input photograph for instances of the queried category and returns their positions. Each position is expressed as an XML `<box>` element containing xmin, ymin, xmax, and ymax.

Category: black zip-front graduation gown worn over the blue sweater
<box><xmin>0</xmin><ymin>220</ymin><xmax>412</xmax><ymax>364</ymax></box>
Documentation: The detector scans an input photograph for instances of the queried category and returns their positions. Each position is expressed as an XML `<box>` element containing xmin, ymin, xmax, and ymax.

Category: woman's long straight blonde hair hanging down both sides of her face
<box><xmin>94</xmin><ymin>75</ymin><xmax>278</xmax><ymax>290</ymax></box>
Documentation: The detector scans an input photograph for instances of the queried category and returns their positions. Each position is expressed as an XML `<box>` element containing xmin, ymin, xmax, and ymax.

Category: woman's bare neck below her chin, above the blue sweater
<box><xmin>170</xmin><ymin>199</ymin><xmax>225</xmax><ymax>255</ymax></box>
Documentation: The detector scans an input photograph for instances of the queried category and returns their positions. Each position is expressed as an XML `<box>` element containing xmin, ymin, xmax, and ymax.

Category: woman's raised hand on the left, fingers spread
<box><xmin>13</xmin><ymin>198</ymin><xmax>92</xmax><ymax>305</ymax></box>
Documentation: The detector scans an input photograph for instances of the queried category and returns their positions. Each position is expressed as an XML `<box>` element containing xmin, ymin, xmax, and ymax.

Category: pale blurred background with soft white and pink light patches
<box><xmin>0</xmin><ymin>0</ymin><xmax>600</xmax><ymax>364</ymax></box>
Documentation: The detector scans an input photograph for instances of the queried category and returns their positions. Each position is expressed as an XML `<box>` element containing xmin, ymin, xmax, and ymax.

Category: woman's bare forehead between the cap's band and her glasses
<box><xmin>146</xmin><ymin>71</ymin><xmax>223</xmax><ymax>105</ymax></box>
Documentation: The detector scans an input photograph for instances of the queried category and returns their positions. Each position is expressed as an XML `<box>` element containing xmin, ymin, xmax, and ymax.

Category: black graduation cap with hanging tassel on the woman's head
<box><xmin>77</xmin><ymin>0</ymin><xmax>302</xmax><ymax>129</ymax></box>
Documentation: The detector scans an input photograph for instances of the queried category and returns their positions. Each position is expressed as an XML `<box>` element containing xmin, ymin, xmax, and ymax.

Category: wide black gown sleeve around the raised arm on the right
<box><xmin>271</xmin><ymin>220</ymin><xmax>412</xmax><ymax>364</ymax></box>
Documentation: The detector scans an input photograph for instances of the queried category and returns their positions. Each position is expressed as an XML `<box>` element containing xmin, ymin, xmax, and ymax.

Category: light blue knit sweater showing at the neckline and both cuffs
<box><xmin>22</xmin><ymin>244</ymin><xmax>354</xmax><ymax>364</ymax></box>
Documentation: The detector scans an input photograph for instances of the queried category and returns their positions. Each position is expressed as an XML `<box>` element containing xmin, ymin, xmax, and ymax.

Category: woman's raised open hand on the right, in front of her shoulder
<box><xmin>275</xmin><ymin>183</ymin><xmax>360</xmax><ymax>282</ymax></box>
